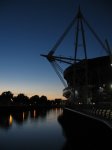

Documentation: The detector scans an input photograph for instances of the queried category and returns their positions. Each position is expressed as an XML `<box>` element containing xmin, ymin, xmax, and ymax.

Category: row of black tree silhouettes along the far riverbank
<box><xmin>0</xmin><ymin>91</ymin><xmax>62</xmax><ymax>108</ymax></box>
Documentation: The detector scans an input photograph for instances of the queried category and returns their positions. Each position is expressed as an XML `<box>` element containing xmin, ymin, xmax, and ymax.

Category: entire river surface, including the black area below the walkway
<box><xmin>0</xmin><ymin>108</ymin><xmax>112</xmax><ymax>150</ymax></box>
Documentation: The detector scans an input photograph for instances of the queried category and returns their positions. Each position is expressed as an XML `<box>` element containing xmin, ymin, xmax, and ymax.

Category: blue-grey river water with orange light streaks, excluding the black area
<box><xmin>0</xmin><ymin>108</ymin><xmax>65</xmax><ymax>150</ymax></box>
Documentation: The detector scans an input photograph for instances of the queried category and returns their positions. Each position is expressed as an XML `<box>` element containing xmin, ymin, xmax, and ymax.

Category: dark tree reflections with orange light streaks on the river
<box><xmin>0</xmin><ymin>109</ymin><xmax>52</xmax><ymax>129</ymax></box>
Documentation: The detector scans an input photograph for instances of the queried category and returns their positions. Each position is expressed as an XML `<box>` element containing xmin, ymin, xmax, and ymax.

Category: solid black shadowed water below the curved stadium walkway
<box><xmin>58</xmin><ymin>109</ymin><xmax>112</xmax><ymax>150</ymax></box>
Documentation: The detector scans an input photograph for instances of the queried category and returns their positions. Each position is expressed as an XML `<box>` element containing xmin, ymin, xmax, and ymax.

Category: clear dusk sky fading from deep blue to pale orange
<box><xmin>0</xmin><ymin>0</ymin><xmax>112</xmax><ymax>99</ymax></box>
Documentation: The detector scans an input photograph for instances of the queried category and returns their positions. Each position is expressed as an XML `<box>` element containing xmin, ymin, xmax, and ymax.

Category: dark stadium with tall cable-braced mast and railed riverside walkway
<box><xmin>41</xmin><ymin>7</ymin><xmax>112</xmax><ymax>129</ymax></box>
